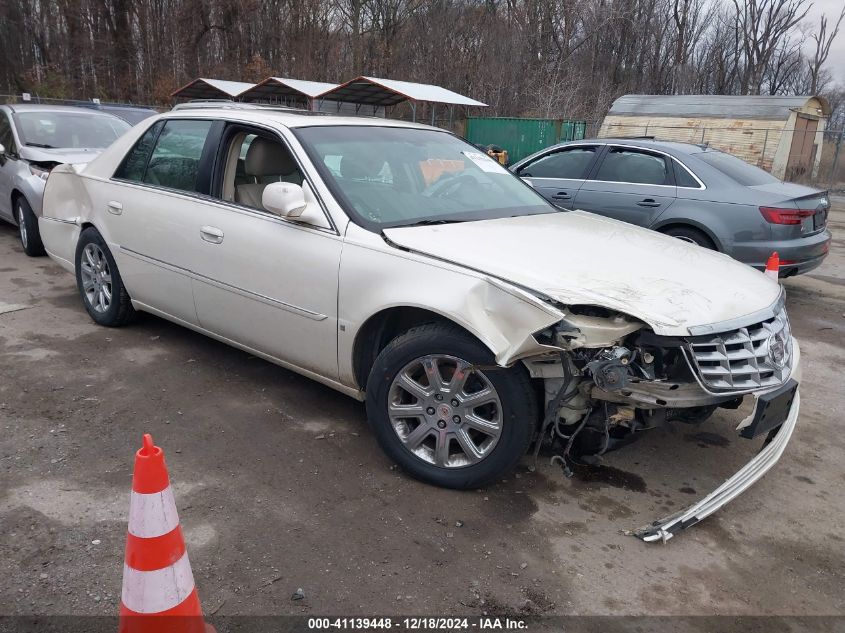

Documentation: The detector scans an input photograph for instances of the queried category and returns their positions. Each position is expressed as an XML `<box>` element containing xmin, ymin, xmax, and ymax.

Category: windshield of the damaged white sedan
<box><xmin>295</xmin><ymin>126</ymin><xmax>558</xmax><ymax>231</ymax></box>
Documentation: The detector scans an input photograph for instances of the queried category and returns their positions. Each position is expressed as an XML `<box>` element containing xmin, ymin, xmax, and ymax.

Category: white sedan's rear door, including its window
<box><xmin>92</xmin><ymin>119</ymin><xmax>222</xmax><ymax>325</ymax></box>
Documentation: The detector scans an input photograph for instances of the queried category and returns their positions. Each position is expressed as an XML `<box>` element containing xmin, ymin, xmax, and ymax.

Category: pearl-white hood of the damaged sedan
<box><xmin>384</xmin><ymin>211</ymin><xmax>780</xmax><ymax>336</ymax></box>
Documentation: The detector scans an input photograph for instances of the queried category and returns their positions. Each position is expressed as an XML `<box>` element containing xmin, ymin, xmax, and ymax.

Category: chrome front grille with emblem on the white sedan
<box><xmin>685</xmin><ymin>309</ymin><xmax>792</xmax><ymax>393</ymax></box>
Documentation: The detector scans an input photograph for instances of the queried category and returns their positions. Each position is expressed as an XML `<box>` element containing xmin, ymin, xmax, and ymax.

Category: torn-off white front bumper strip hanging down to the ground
<box><xmin>631</xmin><ymin>339</ymin><xmax>801</xmax><ymax>543</ymax></box>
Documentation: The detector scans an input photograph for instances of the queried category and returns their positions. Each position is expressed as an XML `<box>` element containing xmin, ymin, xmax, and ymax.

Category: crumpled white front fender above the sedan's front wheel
<box><xmin>338</xmin><ymin>224</ymin><xmax>563</xmax><ymax>387</ymax></box>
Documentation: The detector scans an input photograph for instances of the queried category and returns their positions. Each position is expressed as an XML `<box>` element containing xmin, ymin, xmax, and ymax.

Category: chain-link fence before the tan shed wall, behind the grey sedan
<box><xmin>586</xmin><ymin>121</ymin><xmax>845</xmax><ymax>192</ymax></box>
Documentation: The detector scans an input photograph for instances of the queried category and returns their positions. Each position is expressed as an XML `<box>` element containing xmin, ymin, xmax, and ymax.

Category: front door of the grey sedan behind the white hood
<box><xmin>508</xmin><ymin>145</ymin><xmax>600</xmax><ymax>209</ymax></box>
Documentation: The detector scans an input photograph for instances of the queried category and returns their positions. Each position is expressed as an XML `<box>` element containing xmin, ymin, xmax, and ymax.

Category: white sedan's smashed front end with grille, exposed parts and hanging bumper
<box><xmin>523</xmin><ymin>297</ymin><xmax>800</xmax><ymax>541</ymax></box>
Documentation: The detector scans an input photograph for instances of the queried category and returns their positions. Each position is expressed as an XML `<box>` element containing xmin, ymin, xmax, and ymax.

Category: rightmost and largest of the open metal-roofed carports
<box><xmin>319</xmin><ymin>76</ymin><xmax>487</xmax><ymax>124</ymax></box>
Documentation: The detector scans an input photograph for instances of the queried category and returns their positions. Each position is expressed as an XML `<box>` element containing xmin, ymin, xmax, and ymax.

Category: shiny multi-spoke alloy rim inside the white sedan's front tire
<box><xmin>387</xmin><ymin>355</ymin><xmax>503</xmax><ymax>468</ymax></box>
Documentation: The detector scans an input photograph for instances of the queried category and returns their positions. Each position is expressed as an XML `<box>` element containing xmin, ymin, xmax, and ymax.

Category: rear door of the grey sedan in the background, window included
<box><xmin>574</xmin><ymin>145</ymin><xmax>676</xmax><ymax>227</ymax></box>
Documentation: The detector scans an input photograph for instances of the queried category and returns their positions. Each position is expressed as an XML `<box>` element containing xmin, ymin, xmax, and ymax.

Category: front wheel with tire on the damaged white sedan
<box><xmin>367</xmin><ymin>324</ymin><xmax>537</xmax><ymax>488</ymax></box>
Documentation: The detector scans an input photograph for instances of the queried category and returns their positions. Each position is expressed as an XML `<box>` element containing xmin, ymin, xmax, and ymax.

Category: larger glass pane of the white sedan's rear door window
<box><xmin>143</xmin><ymin>120</ymin><xmax>212</xmax><ymax>191</ymax></box>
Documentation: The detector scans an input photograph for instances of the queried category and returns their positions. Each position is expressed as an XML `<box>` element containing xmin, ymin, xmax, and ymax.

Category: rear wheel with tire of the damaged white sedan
<box><xmin>74</xmin><ymin>227</ymin><xmax>135</xmax><ymax>327</ymax></box>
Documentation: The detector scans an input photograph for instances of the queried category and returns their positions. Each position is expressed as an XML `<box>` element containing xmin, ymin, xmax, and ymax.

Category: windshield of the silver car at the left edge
<box><xmin>14</xmin><ymin>111</ymin><xmax>131</xmax><ymax>149</ymax></box>
